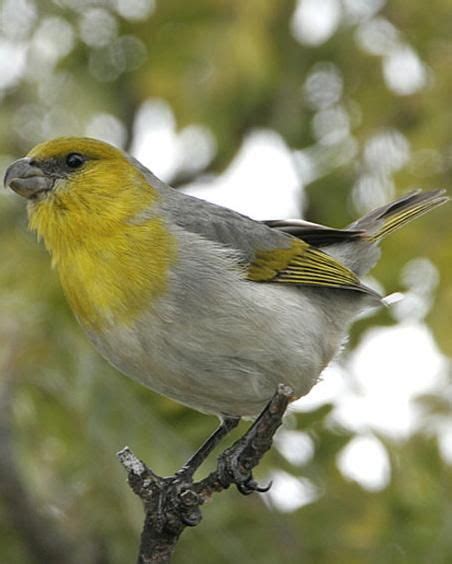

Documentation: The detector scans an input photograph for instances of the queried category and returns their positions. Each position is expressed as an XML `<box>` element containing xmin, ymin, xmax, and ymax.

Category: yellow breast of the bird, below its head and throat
<box><xmin>57</xmin><ymin>219</ymin><xmax>175</xmax><ymax>330</ymax></box>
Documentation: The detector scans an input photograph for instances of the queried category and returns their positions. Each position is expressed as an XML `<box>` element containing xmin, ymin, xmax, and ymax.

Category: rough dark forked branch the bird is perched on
<box><xmin>118</xmin><ymin>384</ymin><xmax>293</xmax><ymax>564</ymax></box>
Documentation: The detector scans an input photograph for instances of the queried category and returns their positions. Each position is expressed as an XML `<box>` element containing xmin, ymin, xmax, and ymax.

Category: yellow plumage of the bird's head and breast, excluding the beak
<box><xmin>23</xmin><ymin>137</ymin><xmax>175</xmax><ymax>329</ymax></box>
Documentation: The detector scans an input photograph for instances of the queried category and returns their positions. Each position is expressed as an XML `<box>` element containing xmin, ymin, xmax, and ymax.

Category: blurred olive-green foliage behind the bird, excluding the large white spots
<box><xmin>0</xmin><ymin>0</ymin><xmax>452</xmax><ymax>564</ymax></box>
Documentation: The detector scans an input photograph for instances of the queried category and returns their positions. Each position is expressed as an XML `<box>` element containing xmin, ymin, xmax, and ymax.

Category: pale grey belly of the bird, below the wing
<box><xmin>85</xmin><ymin>278</ymin><xmax>357</xmax><ymax>416</ymax></box>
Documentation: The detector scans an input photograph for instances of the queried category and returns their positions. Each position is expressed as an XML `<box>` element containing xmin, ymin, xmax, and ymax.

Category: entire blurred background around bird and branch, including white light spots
<box><xmin>0</xmin><ymin>0</ymin><xmax>452</xmax><ymax>564</ymax></box>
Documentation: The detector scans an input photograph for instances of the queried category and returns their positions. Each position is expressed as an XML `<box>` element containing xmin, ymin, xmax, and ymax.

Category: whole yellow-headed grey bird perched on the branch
<box><xmin>4</xmin><ymin>137</ymin><xmax>448</xmax><ymax>473</ymax></box>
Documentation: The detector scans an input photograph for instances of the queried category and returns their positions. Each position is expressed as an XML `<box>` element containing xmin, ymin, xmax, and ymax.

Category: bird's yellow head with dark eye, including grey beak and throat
<box><xmin>4</xmin><ymin>137</ymin><xmax>158</xmax><ymax>243</ymax></box>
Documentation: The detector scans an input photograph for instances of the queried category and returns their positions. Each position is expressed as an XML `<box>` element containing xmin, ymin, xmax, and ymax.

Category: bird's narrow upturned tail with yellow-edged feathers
<box><xmin>349</xmin><ymin>190</ymin><xmax>449</xmax><ymax>243</ymax></box>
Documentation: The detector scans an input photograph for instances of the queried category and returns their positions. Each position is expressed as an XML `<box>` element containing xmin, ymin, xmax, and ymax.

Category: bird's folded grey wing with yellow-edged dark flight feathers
<box><xmin>157</xmin><ymin>189</ymin><xmax>375</xmax><ymax>295</ymax></box>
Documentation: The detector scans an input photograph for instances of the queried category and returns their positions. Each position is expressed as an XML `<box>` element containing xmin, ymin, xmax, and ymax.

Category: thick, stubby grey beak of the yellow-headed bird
<box><xmin>3</xmin><ymin>157</ymin><xmax>55</xmax><ymax>200</ymax></box>
